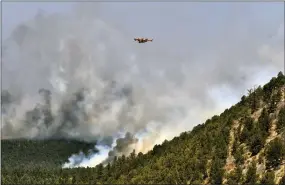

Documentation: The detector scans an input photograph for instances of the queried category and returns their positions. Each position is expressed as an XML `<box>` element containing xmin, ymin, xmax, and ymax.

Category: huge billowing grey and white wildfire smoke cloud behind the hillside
<box><xmin>1</xmin><ymin>3</ymin><xmax>284</xmax><ymax>167</ymax></box>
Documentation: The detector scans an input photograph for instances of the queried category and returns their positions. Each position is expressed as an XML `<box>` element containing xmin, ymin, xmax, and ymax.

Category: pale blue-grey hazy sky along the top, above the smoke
<box><xmin>2</xmin><ymin>2</ymin><xmax>284</xmax><ymax>37</ymax></box>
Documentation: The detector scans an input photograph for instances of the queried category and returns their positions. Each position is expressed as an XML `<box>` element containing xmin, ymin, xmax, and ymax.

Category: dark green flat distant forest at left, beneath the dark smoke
<box><xmin>1</xmin><ymin>139</ymin><xmax>96</xmax><ymax>169</ymax></box>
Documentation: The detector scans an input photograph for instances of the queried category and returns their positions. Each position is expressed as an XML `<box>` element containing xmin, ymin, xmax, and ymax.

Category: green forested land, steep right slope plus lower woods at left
<box><xmin>1</xmin><ymin>72</ymin><xmax>285</xmax><ymax>184</ymax></box>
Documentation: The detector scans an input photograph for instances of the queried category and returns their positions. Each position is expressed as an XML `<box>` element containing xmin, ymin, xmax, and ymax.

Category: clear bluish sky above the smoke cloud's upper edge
<box><xmin>3</xmin><ymin>2</ymin><xmax>284</xmax><ymax>60</ymax></box>
